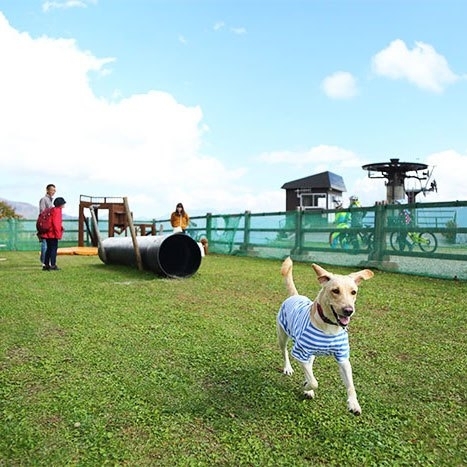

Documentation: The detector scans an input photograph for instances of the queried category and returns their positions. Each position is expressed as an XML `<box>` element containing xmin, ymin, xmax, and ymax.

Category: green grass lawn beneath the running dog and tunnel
<box><xmin>0</xmin><ymin>252</ymin><xmax>467</xmax><ymax>467</ymax></box>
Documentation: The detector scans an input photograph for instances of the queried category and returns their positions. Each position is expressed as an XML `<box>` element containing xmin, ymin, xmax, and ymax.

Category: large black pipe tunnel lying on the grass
<box><xmin>98</xmin><ymin>233</ymin><xmax>201</xmax><ymax>278</ymax></box>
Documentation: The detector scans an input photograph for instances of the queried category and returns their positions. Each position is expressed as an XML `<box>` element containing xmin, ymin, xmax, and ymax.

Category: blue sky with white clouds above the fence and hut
<box><xmin>0</xmin><ymin>0</ymin><xmax>467</xmax><ymax>220</ymax></box>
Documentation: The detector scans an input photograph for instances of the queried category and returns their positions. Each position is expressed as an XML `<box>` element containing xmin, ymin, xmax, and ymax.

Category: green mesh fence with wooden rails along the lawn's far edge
<box><xmin>0</xmin><ymin>201</ymin><xmax>467</xmax><ymax>280</ymax></box>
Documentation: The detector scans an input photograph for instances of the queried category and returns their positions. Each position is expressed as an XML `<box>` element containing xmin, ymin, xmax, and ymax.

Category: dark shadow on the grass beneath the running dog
<box><xmin>150</xmin><ymin>341</ymin><xmax>344</xmax><ymax>423</ymax></box>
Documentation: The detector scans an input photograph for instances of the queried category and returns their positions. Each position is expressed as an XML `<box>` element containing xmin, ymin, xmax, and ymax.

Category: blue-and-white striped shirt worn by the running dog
<box><xmin>277</xmin><ymin>295</ymin><xmax>350</xmax><ymax>363</ymax></box>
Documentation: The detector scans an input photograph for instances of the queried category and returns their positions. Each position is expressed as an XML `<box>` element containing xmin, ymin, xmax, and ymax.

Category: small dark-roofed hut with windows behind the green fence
<box><xmin>281</xmin><ymin>172</ymin><xmax>347</xmax><ymax>211</ymax></box>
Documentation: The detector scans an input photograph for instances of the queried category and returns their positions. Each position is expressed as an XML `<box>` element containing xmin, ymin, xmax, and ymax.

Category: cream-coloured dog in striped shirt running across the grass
<box><xmin>277</xmin><ymin>257</ymin><xmax>374</xmax><ymax>415</ymax></box>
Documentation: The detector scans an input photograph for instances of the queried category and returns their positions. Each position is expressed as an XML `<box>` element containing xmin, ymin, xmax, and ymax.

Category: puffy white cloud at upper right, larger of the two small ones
<box><xmin>372</xmin><ymin>39</ymin><xmax>460</xmax><ymax>93</ymax></box>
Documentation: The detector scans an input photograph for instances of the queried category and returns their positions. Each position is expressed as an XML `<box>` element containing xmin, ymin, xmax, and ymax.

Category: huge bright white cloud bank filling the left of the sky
<box><xmin>0</xmin><ymin>14</ymin><xmax>260</xmax><ymax>218</ymax></box>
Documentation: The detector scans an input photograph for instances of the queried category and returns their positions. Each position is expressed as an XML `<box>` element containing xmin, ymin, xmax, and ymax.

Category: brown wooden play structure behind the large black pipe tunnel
<box><xmin>78</xmin><ymin>195</ymin><xmax>156</xmax><ymax>247</ymax></box>
